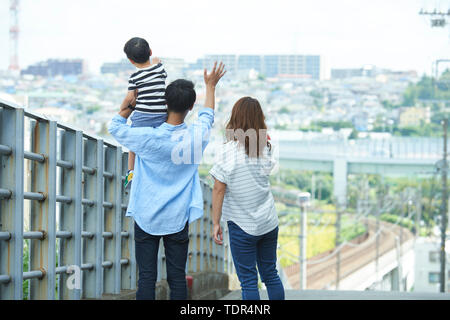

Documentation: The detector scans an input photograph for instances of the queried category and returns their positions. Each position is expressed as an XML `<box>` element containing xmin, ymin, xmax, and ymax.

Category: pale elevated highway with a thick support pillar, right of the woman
<box><xmin>278</xmin><ymin>136</ymin><xmax>443</xmax><ymax>205</ymax></box>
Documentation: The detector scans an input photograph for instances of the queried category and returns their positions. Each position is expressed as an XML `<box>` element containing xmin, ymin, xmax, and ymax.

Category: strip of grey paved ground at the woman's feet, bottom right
<box><xmin>221</xmin><ymin>290</ymin><xmax>450</xmax><ymax>300</ymax></box>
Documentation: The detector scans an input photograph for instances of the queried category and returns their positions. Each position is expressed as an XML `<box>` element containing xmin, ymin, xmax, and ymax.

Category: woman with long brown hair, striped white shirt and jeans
<box><xmin>210</xmin><ymin>97</ymin><xmax>284</xmax><ymax>300</ymax></box>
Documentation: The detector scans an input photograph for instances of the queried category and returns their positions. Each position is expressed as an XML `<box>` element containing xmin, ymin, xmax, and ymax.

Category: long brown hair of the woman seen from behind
<box><xmin>226</xmin><ymin>97</ymin><xmax>271</xmax><ymax>158</ymax></box>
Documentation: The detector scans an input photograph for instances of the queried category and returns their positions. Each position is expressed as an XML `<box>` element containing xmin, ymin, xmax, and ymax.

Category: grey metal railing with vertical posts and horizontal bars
<box><xmin>0</xmin><ymin>101</ymin><xmax>232</xmax><ymax>299</ymax></box>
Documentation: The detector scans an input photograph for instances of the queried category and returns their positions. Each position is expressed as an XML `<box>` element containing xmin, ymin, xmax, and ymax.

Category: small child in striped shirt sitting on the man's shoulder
<box><xmin>123</xmin><ymin>38</ymin><xmax>167</xmax><ymax>188</ymax></box>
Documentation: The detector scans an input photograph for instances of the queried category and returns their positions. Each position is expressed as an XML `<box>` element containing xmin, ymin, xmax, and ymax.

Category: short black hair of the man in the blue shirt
<box><xmin>166</xmin><ymin>79</ymin><xmax>196</xmax><ymax>113</ymax></box>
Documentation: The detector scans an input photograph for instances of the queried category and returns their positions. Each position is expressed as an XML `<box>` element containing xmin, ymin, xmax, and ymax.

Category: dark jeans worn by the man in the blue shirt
<box><xmin>134</xmin><ymin>222</ymin><xmax>189</xmax><ymax>300</ymax></box>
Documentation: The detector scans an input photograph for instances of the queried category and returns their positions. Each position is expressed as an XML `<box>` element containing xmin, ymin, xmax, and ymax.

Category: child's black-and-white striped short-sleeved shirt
<box><xmin>128</xmin><ymin>63</ymin><xmax>167</xmax><ymax>113</ymax></box>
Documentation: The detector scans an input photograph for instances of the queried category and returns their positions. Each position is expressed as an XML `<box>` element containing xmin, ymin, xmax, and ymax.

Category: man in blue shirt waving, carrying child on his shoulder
<box><xmin>109</xmin><ymin>63</ymin><xmax>226</xmax><ymax>300</ymax></box>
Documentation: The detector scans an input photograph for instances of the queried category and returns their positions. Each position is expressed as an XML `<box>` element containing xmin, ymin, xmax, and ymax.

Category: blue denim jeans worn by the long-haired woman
<box><xmin>228</xmin><ymin>221</ymin><xmax>284</xmax><ymax>300</ymax></box>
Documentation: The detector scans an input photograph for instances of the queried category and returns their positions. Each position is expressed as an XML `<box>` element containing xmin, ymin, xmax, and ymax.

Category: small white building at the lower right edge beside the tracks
<box><xmin>414</xmin><ymin>238</ymin><xmax>450</xmax><ymax>292</ymax></box>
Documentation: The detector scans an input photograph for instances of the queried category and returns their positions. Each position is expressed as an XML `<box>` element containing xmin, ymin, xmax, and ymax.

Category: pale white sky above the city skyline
<box><xmin>0</xmin><ymin>0</ymin><xmax>450</xmax><ymax>74</ymax></box>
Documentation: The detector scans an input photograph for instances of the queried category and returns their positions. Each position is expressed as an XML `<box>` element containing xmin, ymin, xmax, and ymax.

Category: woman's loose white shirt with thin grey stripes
<box><xmin>209</xmin><ymin>141</ymin><xmax>278</xmax><ymax>236</ymax></box>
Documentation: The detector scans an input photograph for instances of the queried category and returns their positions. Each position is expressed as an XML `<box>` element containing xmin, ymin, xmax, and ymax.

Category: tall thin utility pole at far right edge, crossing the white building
<box><xmin>440</xmin><ymin>118</ymin><xmax>448</xmax><ymax>292</ymax></box>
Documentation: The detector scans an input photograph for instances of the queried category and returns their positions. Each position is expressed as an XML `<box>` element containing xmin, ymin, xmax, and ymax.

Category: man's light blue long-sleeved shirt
<box><xmin>109</xmin><ymin>108</ymin><xmax>214</xmax><ymax>235</ymax></box>
